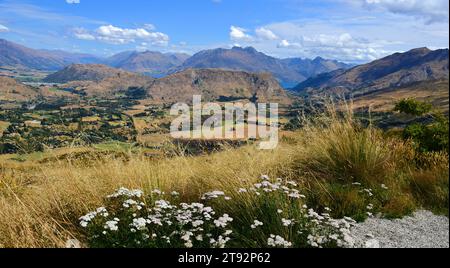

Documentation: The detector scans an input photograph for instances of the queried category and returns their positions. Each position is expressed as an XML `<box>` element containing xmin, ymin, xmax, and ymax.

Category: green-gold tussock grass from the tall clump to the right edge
<box><xmin>292</xmin><ymin>104</ymin><xmax>448</xmax><ymax>221</ymax></box>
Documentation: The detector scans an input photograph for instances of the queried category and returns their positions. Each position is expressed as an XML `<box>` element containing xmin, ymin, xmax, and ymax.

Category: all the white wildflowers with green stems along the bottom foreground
<box><xmin>80</xmin><ymin>178</ymin><xmax>362</xmax><ymax>248</ymax></box>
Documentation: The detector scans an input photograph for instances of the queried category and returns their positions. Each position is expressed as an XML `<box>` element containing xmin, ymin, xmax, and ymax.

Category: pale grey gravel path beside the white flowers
<box><xmin>352</xmin><ymin>211</ymin><xmax>449</xmax><ymax>248</ymax></box>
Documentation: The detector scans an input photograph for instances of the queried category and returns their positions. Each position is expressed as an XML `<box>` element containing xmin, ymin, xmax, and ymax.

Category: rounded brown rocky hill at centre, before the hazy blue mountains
<box><xmin>148</xmin><ymin>69</ymin><xmax>290</xmax><ymax>103</ymax></box>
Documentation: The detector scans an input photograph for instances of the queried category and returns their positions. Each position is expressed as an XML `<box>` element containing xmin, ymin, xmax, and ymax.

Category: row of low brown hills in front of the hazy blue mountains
<box><xmin>0</xmin><ymin>64</ymin><xmax>291</xmax><ymax>104</ymax></box>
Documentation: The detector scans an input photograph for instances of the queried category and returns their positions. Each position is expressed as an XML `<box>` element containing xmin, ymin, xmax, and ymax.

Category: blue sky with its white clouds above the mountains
<box><xmin>0</xmin><ymin>0</ymin><xmax>449</xmax><ymax>62</ymax></box>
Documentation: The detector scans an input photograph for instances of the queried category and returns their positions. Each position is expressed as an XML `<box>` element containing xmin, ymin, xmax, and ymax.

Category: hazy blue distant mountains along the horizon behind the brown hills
<box><xmin>0</xmin><ymin>39</ymin><xmax>351</xmax><ymax>88</ymax></box>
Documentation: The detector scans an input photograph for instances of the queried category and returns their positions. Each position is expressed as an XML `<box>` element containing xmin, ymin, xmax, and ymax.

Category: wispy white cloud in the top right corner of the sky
<box><xmin>349</xmin><ymin>0</ymin><xmax>449</xmax><ymax>23</ymax></box>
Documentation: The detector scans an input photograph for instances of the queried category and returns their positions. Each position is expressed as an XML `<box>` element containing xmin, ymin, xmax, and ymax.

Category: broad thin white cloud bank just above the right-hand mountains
<box><xmin>251</xmin><ymin>15</ymin><xmax>449</xmax><ymax>63</ymax></box>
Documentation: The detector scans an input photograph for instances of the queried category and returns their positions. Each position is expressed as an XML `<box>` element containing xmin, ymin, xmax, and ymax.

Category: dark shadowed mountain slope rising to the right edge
<box><xmin>294</xmin><ymin>48</ymin><xmax>449</xmax><ymax>96</ymax></box>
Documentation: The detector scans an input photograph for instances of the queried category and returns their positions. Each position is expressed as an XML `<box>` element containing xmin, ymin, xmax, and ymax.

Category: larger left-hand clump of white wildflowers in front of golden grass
<box><xmin>80</xmin><ymin>188</ymin><xmax>233</xmax><ymax>248</ymax></box>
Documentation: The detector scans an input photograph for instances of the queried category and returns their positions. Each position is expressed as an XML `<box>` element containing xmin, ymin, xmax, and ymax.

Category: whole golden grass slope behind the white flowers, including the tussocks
<box><xmin>0</xmin><ymin>109</ymin><xmax>448</xmax><ymax>247</ymax></box>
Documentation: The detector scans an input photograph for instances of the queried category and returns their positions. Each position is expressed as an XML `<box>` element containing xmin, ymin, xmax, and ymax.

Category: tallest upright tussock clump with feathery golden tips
<box><xmin>296</xmin><ymin>107</ymin><xmax>403</xmax><ymax>183</ymax></box>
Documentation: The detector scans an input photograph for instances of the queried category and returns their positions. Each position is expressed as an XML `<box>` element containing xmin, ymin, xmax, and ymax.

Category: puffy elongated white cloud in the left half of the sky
<box><xmin>74</xmin><ymin>25</ymin><xmax>169</xmax><ymax>46</ymax></box>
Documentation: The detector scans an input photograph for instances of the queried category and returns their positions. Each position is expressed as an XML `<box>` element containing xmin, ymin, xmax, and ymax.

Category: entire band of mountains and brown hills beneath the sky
<box><xmin>0</xmin><ymin>37</ymin><xmax>449</xmax><ymax>108</ymax></box>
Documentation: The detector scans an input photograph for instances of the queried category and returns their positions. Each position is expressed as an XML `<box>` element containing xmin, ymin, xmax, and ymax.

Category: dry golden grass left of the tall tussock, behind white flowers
<box><xmin>0</xmin><ymin>142</ymin><xmax>290</xmax><ymax>247</ymax></box>
